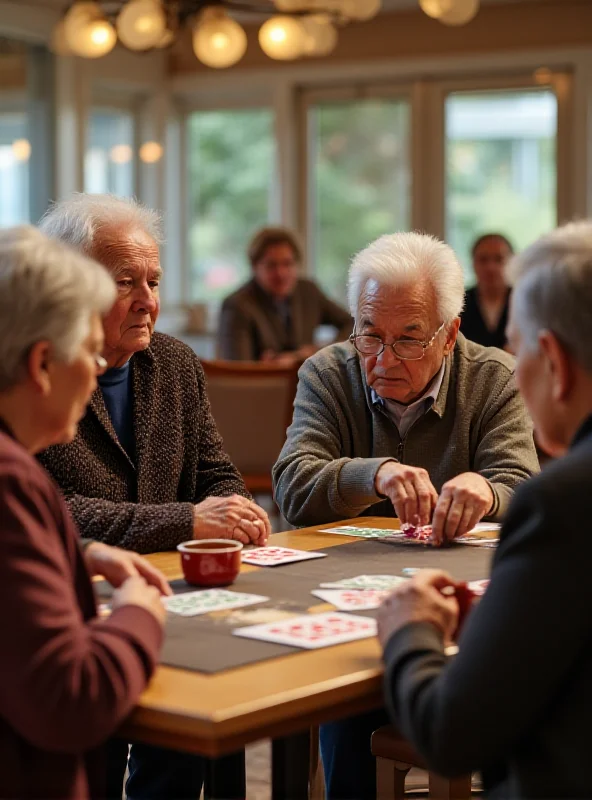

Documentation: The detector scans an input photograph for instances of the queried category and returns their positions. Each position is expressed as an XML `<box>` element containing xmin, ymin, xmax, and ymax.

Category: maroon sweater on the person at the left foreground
<box><xmin>0</xmin><ymin>421</ymin><xmax>162</xmax><ymax>800</ymax></box>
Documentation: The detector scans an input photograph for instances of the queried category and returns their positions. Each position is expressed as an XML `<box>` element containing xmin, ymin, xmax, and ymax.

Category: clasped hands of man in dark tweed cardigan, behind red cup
<box><xmin>193</xmin><ymin>494</ymin><xmax>271</xmax><ymax>545</ymax></box>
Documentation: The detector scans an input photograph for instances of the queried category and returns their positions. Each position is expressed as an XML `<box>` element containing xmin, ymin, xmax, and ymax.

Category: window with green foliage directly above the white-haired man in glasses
<box><xmin>307</xmin><ymin>97</ymin><xmax>411</xmax><ymax>302</ymax></box>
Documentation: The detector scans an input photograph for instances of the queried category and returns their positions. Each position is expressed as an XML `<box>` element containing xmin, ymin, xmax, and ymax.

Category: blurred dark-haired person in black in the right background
<box><xmin>460</xmin><ymin>233</ymin><xmax>514</xmax><ymax>350</ymax></box>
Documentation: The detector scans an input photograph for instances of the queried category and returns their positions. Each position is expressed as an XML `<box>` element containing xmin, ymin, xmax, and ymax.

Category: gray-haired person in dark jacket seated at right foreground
<box><xmin>379</xmin><ymin>217</ymin><xmax>592</xmax><ymax>800</ymax></box>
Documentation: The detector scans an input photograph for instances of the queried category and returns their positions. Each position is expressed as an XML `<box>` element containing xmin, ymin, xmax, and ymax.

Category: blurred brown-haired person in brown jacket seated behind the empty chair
<box><xmin>218</xmin><ymin>228</ymin><xmax>352</xmax><ymax>364</ymax></box>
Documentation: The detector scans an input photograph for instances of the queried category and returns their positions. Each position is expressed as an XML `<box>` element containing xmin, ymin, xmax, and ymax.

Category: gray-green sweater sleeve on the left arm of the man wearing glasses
<box><xmin>273</xmin><ymin>359</ymin><xmax>391</xmax><ymax>525</ymax></box>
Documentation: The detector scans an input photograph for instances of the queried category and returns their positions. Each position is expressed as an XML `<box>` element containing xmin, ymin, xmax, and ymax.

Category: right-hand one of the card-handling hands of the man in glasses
<box><xmin>432</xmin><ymin>472</ymin><xmax>494</xmax><ymax>544</ymax></box>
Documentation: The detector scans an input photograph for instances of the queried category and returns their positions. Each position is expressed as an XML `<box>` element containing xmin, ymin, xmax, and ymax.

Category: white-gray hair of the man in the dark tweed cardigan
<box><xmin>39</xmin><ymin>193</ymin><xmax>162</xmax><ymax>253</ymax></box>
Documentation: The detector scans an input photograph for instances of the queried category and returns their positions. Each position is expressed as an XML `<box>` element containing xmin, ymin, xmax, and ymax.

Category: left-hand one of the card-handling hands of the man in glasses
<box><xmin>374</xmin><ymin>461</ymin><xmax>438</xmax><ymax>525</ymax></box>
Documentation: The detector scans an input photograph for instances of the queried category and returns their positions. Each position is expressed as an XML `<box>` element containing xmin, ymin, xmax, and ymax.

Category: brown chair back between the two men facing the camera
<box><xmin>201</xmin><ymin>360</ymin><xmax>300</xmax><ymax>494</ymax></box>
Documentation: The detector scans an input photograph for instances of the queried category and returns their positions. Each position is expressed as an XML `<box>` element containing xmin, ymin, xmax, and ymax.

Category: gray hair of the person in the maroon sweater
<box><xmin>0</xmin><ymin>225</ymin><xmax>116</xmax><ymax>391</ymax></box>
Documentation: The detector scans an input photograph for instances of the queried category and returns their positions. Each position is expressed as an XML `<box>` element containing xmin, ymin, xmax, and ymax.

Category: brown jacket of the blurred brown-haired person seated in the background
<box><xmin>218</xmin><ymin>278</ymin><xmax>353</xmax><ymax>361</ymax></box>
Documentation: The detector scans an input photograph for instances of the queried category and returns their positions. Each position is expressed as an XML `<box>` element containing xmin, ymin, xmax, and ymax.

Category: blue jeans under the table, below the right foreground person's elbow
<box><xmin>320</xmin><ymin>709</ymin><xmax>389</xmax><ymax>800</ymax></box>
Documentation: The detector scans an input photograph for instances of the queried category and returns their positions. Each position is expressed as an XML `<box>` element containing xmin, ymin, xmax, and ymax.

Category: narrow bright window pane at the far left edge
<box><xmin>0</xmin><ymin>111</ymin><xmax>31</xmax><ymax>227</ymax></box>
